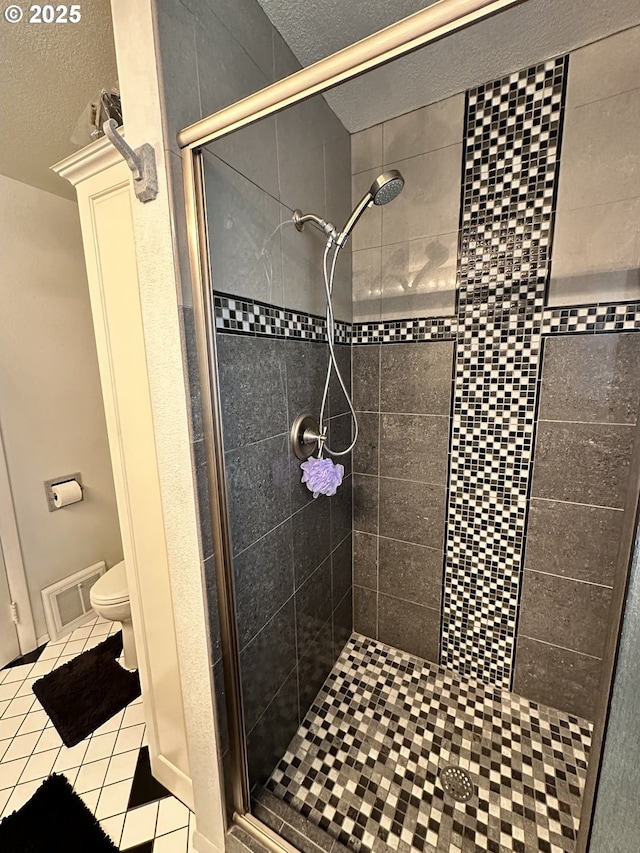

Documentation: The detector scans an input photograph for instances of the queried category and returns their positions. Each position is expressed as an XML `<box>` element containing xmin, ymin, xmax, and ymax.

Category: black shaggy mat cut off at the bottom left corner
<box><xmin>0</xmin><ymin>774</ymin><xmax>118</xmax><ymax>853</ymax></box>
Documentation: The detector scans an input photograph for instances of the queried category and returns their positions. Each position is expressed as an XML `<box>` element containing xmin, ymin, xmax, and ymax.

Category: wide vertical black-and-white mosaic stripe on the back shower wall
<box><xmin>440</xmin><ymin>58</ymin><xmax>567</xmax><ymax>688</ymax></box>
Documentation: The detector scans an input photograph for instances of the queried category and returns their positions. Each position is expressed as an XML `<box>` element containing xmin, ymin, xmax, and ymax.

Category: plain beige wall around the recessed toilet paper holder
<box><xmin>0</xmin><ymin>176</ymin><xmax>122</xmax><ymax>637</ymax></box>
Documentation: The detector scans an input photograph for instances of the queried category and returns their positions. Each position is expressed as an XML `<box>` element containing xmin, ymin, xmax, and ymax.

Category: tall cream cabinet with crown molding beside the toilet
<box><xmin>55</xmin><ymin>139</ymin><xmax>193</xmax><ymax>808</ymax></box>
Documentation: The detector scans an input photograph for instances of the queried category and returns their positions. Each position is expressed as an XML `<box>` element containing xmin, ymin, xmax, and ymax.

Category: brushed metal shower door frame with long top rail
<box><xmin>177</xmin><ymin>0</ymin><xmax>640</xmax><ymax>853</ymax></box>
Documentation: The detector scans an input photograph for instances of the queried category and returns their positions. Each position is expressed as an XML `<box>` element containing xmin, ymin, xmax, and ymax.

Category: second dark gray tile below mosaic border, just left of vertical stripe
<box><xmin>380</xmin><ymin>414</ymin><xmax>449</xmax><ymax>485</ymax></box>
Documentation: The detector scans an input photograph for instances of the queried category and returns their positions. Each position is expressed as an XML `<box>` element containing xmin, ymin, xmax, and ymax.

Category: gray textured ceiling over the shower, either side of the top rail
<box><xmin>259</xmin><ymin>0</ymin><xmax>640</xmax><ymax>133</ymax></box>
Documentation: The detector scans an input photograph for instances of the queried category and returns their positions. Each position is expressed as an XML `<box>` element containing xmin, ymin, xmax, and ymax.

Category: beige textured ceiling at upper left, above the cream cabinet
<box><xmin>0</xmin><ymin>0</ymin><xmax>117</xmax><ymax>198</ymax></box>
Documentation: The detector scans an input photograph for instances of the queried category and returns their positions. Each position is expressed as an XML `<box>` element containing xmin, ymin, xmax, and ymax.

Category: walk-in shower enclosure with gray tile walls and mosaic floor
<box><xmin>181</xmin><ymin>4</ymin><xmax>640</xmax><ymax>853</ymax></box>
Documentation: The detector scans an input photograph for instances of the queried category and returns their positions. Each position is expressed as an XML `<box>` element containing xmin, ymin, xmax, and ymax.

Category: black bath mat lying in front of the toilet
<box><xmin>33</xmin><ymin>631</ymin><xmax>140</xmax><ymax>747</ymax></box>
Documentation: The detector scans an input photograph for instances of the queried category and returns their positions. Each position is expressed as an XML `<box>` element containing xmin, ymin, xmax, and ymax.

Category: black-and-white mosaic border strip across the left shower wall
<box><xmin>213</xmin><ymin>293</ymin><xmax>351</xmax><ymax>344</ymax></box>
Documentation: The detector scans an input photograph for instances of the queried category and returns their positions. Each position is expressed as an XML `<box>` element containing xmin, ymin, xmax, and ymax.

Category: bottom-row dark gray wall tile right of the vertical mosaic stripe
<box><xmin>513</xmin><ymin>637</ymin><xmax>602</xmax><ymax>720</ymax></box>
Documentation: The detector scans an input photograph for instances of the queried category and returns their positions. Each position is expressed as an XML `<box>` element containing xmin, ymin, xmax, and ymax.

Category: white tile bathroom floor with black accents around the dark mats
<box><xmin>0</xmin><ymin>618</ymin><xmax>194</xmax><ymax>853</ymax></box>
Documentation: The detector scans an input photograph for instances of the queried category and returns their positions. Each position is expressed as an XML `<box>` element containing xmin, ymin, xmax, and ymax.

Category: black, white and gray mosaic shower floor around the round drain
<box><xmin>265</xmin><ymin>634</ymin><xmax>592</xmax><ymax>853</ymax></box>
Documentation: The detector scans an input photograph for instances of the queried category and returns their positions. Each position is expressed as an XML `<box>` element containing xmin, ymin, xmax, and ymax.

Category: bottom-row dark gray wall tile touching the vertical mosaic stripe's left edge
<box><xmin>378</xmin><ymin>595</ymin><xmax>440</xmax><ymax>662</ymax></box>
